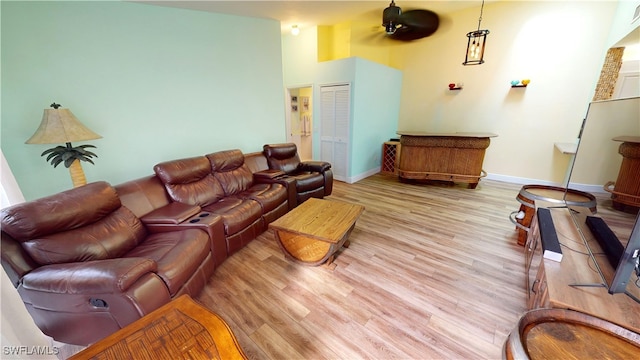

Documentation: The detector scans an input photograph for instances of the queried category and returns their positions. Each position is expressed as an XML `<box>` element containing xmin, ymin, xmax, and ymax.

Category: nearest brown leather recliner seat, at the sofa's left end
<box><xmin>0</xmin><ymin>182</ymin><xmax>215</xmax><ymax>345</ymax></box>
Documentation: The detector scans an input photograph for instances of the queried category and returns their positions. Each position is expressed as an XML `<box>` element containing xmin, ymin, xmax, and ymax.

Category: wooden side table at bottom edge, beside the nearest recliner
<box><xmin>70</xmin><ymin>295</ymin><xmax>247</xmax><ymax>360</ymax></box>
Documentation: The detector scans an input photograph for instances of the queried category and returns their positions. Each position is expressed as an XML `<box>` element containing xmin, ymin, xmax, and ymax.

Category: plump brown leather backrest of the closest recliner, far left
<box><xmin>2</xmin><ymin>182</ymin><xmax>146</xmax><ymax>265</ymax></box>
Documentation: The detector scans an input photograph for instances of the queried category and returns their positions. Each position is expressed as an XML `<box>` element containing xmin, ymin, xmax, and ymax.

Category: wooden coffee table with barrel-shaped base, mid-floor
<box><xmin>269</xmin><ymin>198</ymin><xmax>364</xmax><ymax>266</ymax></box>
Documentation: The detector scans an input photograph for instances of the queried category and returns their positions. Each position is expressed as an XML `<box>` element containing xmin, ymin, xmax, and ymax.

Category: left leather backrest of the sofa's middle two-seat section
<box><xmin>153</xmin><ymin>156</ymin><xmax>225</xmax><ymax>207</ymax></box>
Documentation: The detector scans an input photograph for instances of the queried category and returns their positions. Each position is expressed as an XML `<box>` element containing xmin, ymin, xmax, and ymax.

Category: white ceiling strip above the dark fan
<box><xmin>135</xmin><ymin>0</ymin><xmax>484</xmax><ymax>32</ymax></box>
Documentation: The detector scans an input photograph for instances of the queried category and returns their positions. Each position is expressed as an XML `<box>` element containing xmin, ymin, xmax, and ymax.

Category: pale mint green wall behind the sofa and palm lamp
<box><xmin>0</xmin><ymin>1</ymin><xmax>285</xmax><ymax>200</ymax></box>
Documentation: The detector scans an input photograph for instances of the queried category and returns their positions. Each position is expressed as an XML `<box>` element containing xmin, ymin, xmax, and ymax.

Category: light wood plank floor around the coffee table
<box><xmin>197</xmin><ymin>174</ymin><xmax>526</xmax><ymax>359</ymax></box>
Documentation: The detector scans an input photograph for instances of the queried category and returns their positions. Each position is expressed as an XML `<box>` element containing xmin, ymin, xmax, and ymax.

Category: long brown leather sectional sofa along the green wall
<box><xmin>0</xmin><ymin>146</ymin><xmax>333</xmax><ymax>345</ymax></box>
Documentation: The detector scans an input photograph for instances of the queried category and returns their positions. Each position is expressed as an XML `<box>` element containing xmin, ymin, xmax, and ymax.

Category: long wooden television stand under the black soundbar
<box><xmin>525</xmin><ymin>203</ymin><xmax>640</xmax><ymax>333</ymax></box>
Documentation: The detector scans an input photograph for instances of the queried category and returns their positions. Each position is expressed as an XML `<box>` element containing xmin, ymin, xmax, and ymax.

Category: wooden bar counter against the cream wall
<box><xmin>397</xmin><ymin>131</ymin><xmax>498</xmax><ymax>189</ymax></box>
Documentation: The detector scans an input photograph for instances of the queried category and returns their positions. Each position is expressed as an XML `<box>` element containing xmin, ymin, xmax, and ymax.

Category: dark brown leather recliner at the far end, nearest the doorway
<box><xmin>262</xmin><ymin>143</ymin><xmax>333</xmax><ymax>205</ymax></box>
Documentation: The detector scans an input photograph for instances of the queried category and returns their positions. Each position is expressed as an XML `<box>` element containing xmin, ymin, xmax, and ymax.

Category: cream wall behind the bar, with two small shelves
<box><xmin>399</xmin><ymin>1</ymin><xmax>616</xmax><ymax>184</ymax></box>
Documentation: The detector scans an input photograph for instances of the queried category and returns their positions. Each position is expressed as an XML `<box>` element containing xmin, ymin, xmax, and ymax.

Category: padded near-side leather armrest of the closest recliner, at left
<box><xmin>22</xmin><ymin>258</ymin><xmax>158</xmax><ymax>294</ymax></box>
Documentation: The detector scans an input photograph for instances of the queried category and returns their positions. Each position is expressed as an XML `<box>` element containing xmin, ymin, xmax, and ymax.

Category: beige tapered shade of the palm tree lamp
<box><xmin>25</xmin><ymin>108</ymin><xmax>102</xmax><ymax>144</ymax></box>
